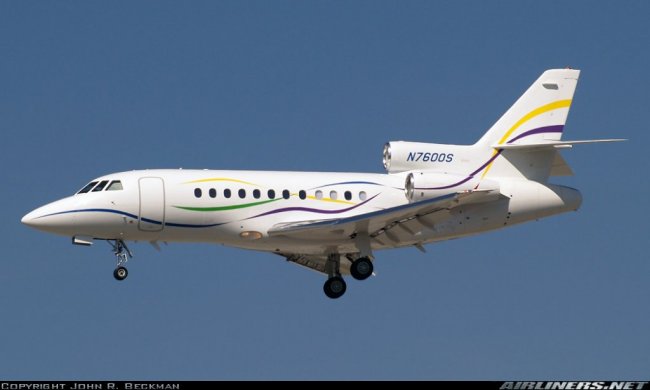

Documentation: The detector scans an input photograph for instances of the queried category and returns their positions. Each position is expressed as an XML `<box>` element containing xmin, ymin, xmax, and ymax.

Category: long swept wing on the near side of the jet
<box><xmin>268</xmin><ymin>190</ymin><xmax>501</xmax><ymax>240</ymax></box>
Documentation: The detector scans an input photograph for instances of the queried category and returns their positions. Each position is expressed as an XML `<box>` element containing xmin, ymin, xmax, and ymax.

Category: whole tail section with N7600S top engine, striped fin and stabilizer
<box><xmin>384</xmin><ymin>69</ymin><xmax>621</xmax><ymax>184</ymax></box>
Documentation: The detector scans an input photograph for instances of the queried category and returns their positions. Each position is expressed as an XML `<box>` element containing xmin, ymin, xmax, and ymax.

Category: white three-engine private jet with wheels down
<box><xmin>22</xmin><ymin>68</ymin><xmax>624</xmax><ymax>299</ymax></box>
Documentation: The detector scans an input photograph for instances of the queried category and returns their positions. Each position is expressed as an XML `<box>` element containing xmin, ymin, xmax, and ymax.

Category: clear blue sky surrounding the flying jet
<box><xmin>0</xmin><ymin>1</ymin><xmax>650</xmax><ymax>380</ymax></box>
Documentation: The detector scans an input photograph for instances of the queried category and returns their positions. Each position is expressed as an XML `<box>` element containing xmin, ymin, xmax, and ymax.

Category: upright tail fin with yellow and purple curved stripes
<box><xmin>474</xmin><ymin>69</ymin><xmax>580</xmax><ymax>182</ymax></box>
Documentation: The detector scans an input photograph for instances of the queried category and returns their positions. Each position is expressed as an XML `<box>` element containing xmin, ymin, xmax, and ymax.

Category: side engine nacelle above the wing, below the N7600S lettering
<box><xmin>404</xmin><ymin>172</ymin><xmax>499</xmax><ymax>202</ymax></box>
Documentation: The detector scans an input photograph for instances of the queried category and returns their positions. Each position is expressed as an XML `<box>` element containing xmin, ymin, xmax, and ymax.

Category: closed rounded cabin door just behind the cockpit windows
<box><xmin>138</xmin><ymin>177</ymin><xmax>165</xmax><ymax>232</ymax></box>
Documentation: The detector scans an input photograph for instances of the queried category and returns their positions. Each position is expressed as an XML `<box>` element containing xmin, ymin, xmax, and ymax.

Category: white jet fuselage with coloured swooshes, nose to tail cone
<box><xmin>23</xmin><ymin>169</ymin><xmax>580</xmax><ymax>254</ymax></box>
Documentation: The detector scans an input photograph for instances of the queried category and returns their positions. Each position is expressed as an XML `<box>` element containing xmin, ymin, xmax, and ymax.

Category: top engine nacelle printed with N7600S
<box><xmin>383</xmin><ymin>141</ymin><xmax>463</xmax><ymax>173</ymax></box>
